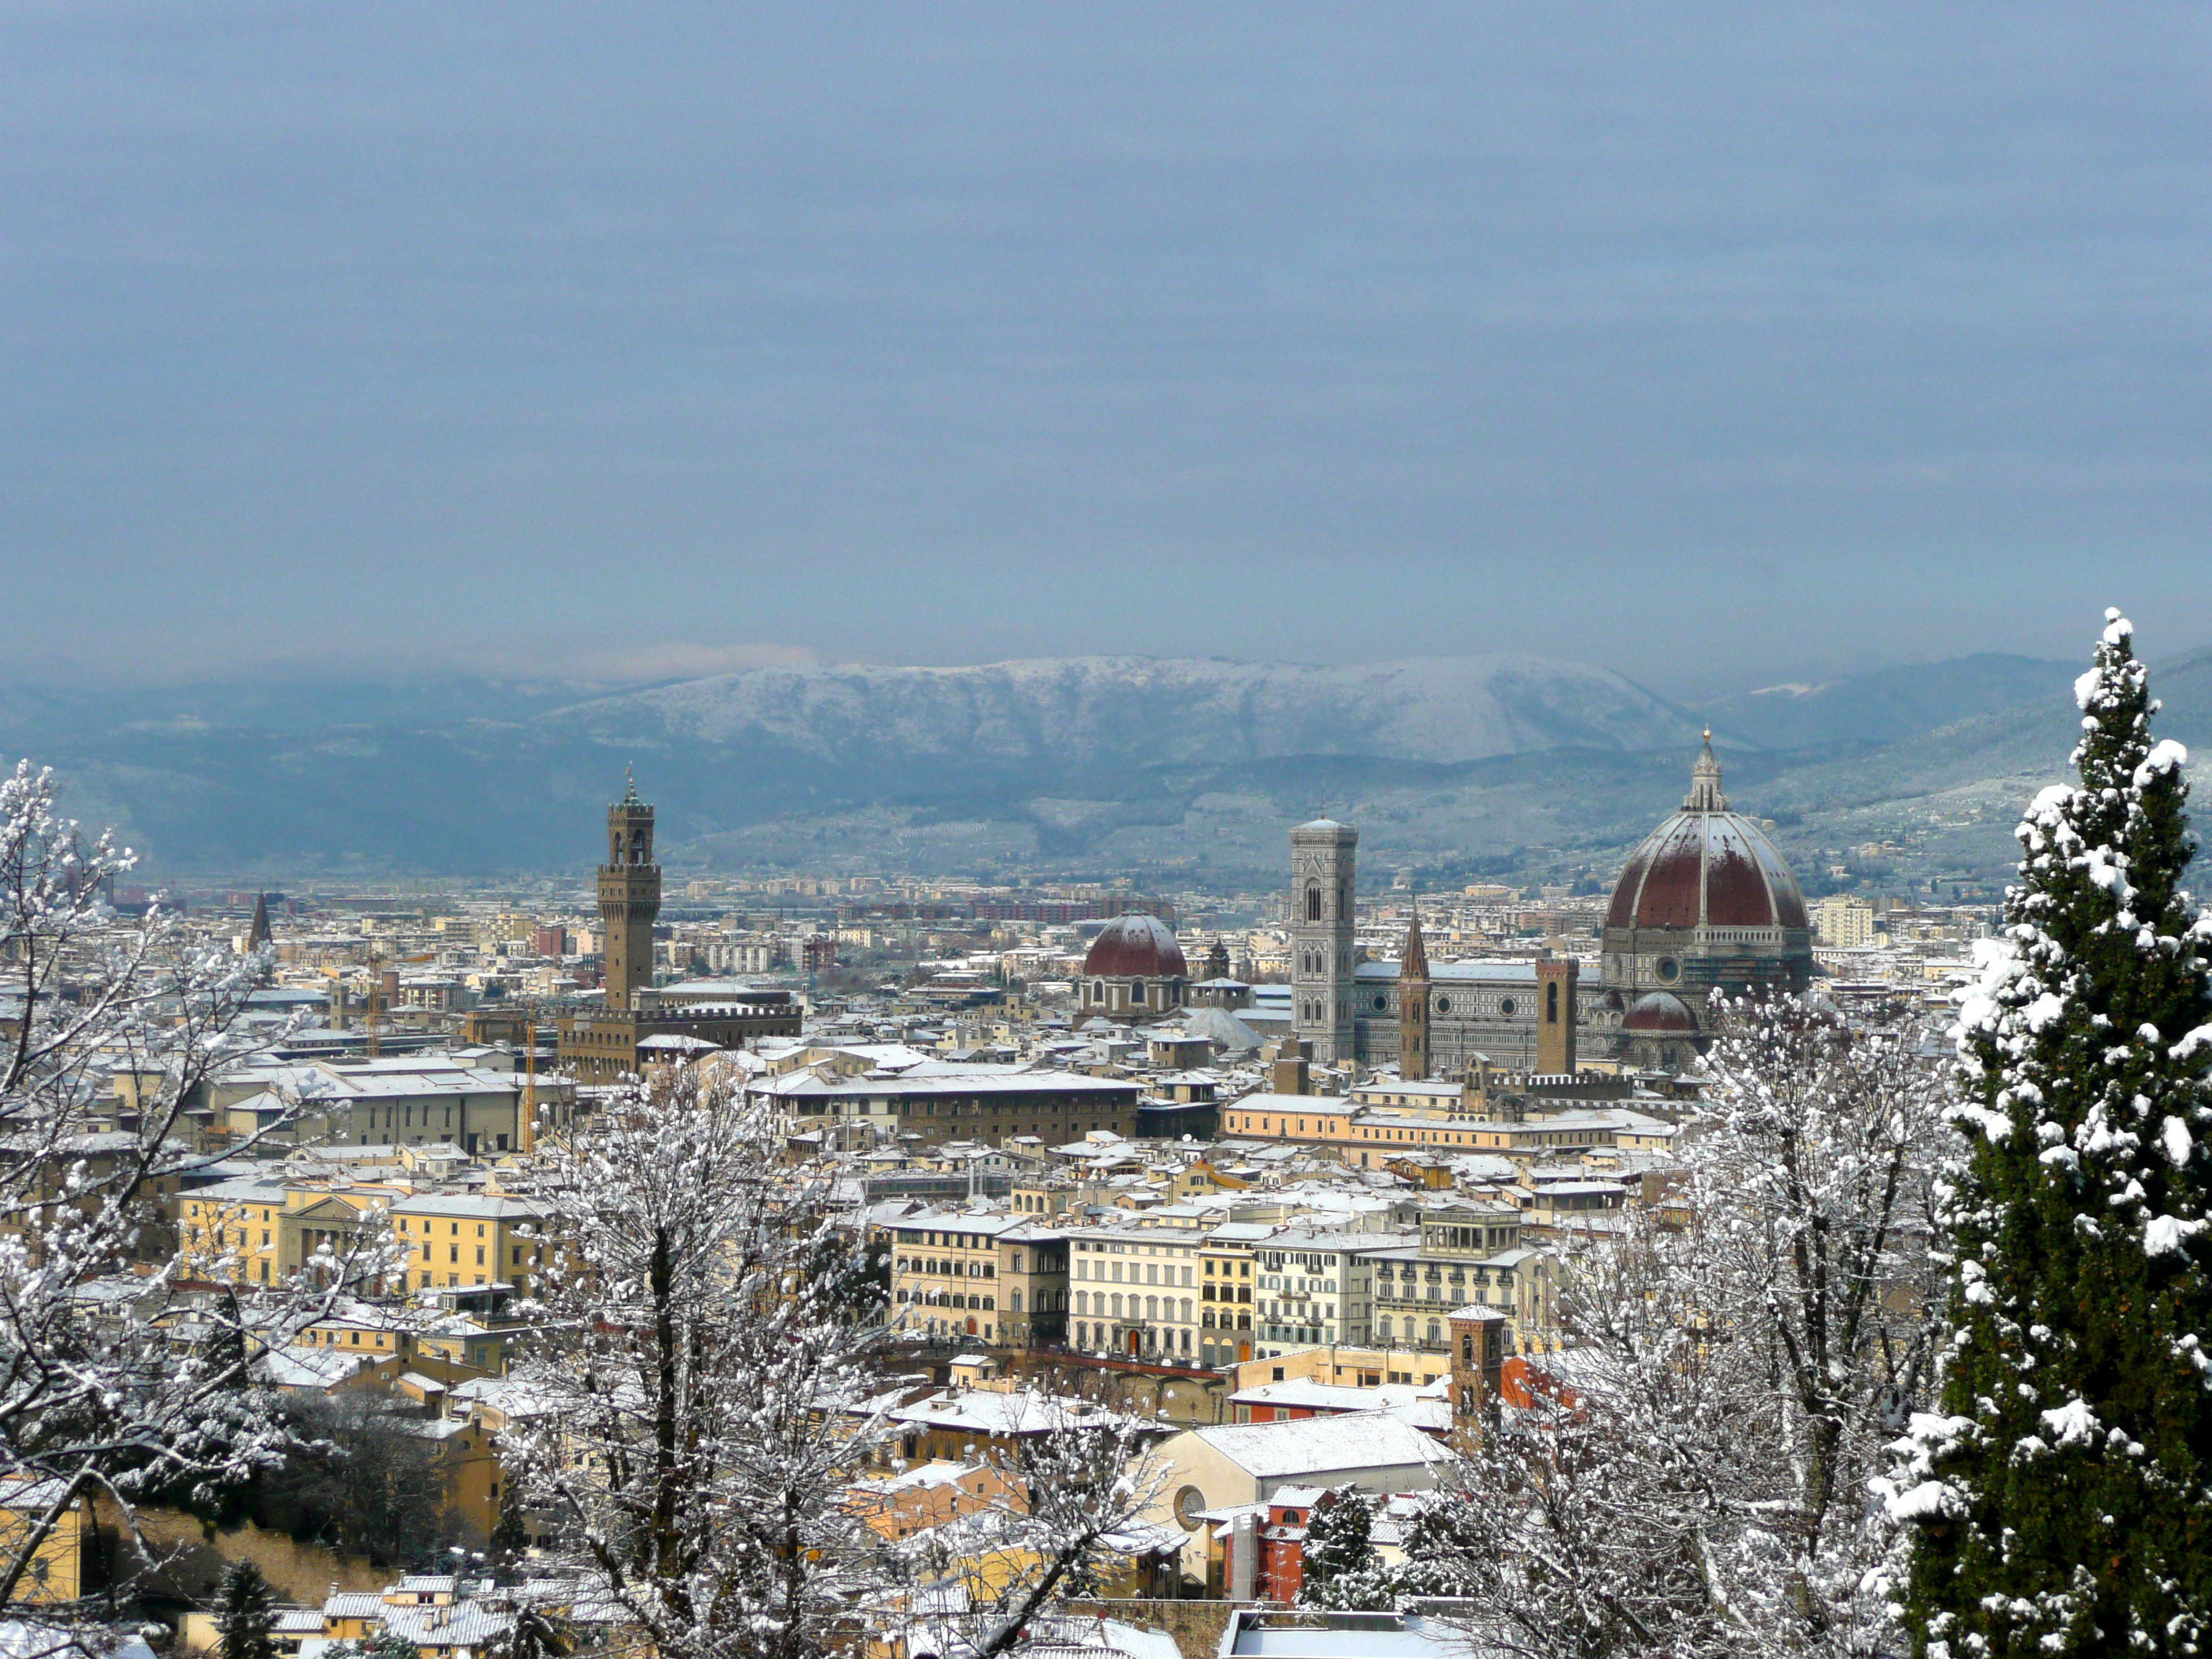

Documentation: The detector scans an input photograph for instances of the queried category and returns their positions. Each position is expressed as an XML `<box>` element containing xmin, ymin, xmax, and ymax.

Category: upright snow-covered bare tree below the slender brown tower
<box><xmin>504</xmin><ymin>1071</ymin><xmax>881</xmax><ymax>1659</ymax></box>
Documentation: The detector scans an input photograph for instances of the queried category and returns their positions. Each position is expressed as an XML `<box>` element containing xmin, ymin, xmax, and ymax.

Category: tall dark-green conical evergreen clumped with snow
<box><xmin>1887</xmin><ymin>611</ymin><xmax>2212</xmax><ymax>1659</ymax></box>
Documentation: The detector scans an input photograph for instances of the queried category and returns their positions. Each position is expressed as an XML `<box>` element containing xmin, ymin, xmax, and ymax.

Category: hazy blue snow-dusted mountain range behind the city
<box><xmin>0</xmin><ymin>652</ymin><xmax>2212</xmax><ymax>878</ymax></box>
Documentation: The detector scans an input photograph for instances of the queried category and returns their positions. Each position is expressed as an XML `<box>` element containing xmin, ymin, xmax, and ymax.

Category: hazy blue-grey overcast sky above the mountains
<box><xmin>0</xmin><ymin>0</ymin><xmax>2212</xmax><ymax>693</ymax></box>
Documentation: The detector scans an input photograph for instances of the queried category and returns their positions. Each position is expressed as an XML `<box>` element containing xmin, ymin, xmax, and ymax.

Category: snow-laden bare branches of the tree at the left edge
<box><xmin>0</xmin><ymin>763</ymin><xmax>387</xmax><ymax>1601</ymax></box>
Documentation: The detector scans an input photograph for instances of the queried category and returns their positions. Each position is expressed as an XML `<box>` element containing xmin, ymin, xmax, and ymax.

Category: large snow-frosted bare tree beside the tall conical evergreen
<box><xmin>1422</xmin><ymin>1000</ymin><xmax>1948</xmax><ymax>1659</ymax></box>
